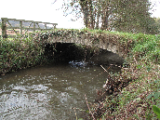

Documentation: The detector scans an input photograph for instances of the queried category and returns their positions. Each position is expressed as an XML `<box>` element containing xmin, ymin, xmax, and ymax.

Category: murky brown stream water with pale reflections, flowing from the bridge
<box><xmin>0</xmin><ymin>61</ymin><xmax>119</xmax><ymax>120</ymax></box>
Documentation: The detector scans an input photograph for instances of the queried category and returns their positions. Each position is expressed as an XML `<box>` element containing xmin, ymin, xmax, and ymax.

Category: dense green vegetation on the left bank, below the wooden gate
<box><xmin>0</xmin><ymin>34</ymin><xmax>44</xmax><ymax>75</ymax></box>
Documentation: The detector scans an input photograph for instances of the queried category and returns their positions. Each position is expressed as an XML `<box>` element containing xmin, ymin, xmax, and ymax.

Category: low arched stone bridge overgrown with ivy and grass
<box><xmin>35</xmin><ymin>29</ymin><xmax>129</xmax><ymax>56</ymax></box>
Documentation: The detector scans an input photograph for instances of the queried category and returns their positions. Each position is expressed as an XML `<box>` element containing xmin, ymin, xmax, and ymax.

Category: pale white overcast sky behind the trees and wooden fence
<box><xmin>0</xmin><ymin>0</ymin><xmax>160</xmax><ymax>29</ymax></box>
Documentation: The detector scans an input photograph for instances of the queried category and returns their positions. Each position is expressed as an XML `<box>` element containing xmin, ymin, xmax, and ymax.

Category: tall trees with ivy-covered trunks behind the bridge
<box><xmin>54</xmin><ymin>0</ymin><xmax>158</xmax><ymax>34</ymax></box>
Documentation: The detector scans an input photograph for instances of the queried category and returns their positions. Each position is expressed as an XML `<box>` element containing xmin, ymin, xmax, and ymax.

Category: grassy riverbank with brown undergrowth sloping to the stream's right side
<box><xmin>87</xmin><ymin>30</ymin><xmax>160</xmax><ymax>120</ymax></box>
